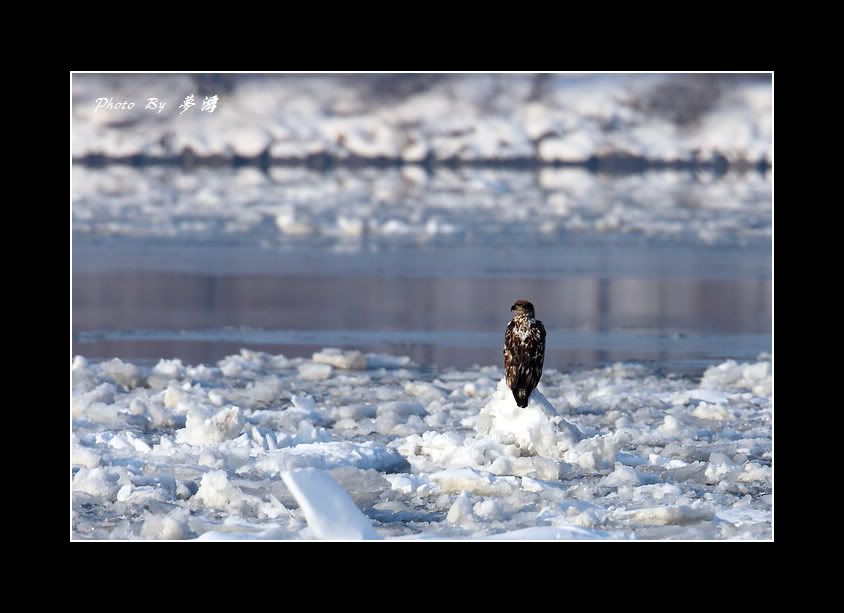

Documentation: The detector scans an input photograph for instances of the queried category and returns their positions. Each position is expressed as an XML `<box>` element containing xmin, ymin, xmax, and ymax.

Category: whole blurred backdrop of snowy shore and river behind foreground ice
<box><xmin>72</xmin><ymin>74</ymin><xmax>772</xmax><ymax>373</ymax></box>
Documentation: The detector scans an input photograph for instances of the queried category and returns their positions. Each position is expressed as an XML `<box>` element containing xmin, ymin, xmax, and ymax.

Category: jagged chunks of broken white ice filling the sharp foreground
<box><xmin>71</xmin><ymin>350</ymin><xmax>772</xmax><ymax>539</ymax></box>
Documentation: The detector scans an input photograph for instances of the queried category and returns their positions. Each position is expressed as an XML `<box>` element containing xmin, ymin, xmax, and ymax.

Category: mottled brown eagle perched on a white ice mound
<box><xmin>504</xmin><ymin>300</ymin><xmax>545</xmax><ymax>408</ymax></box>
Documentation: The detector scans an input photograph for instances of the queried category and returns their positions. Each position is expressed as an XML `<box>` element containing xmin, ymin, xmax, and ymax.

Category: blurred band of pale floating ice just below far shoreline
<box><xmin>72</xmin><ymin>166</ymin><xmax>772</xmax><ymax>252</ymax></box>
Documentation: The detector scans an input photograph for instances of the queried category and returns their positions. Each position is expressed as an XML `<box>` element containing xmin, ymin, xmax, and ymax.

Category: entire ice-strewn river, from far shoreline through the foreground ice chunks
<box><xmin>71</xmin><ymin>167</ymin><xmax>773</xmax><ymax>539</ymax></box>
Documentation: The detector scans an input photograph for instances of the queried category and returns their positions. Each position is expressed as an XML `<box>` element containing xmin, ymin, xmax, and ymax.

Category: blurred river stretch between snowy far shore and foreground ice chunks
<box><xmin>73</xmin><ymin>168</ymin><xmax>771</xmax><ymax>368</ymax></box>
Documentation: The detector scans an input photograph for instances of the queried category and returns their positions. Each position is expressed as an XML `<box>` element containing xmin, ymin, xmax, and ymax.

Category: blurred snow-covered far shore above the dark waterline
<box><xmin>72</xmin><ymin>74</ymin><xmax>772</xmax><ymax>169</ymax></box>
